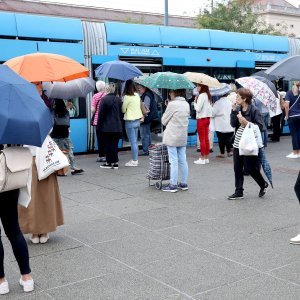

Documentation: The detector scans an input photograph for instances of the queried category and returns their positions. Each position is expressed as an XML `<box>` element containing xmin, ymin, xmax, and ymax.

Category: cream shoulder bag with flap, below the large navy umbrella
<box><xmin>0</xmin><ymin>147</ymin><xmax>32</xmax><ymax>193</ymax></box>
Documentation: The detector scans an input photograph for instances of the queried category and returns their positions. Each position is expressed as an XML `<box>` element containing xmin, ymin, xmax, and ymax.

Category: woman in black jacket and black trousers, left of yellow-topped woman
<box><xmin>97</xmin><ymin>83</ymin><xmax>123</xmax><ymax>169</ymax></box>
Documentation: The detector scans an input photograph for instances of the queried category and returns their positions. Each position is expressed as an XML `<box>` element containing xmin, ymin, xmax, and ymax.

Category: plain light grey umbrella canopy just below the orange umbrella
<box><xmin>43</xmin><ymin>77</ymin><xmax>95</xmax><ymax>99</ymax></box>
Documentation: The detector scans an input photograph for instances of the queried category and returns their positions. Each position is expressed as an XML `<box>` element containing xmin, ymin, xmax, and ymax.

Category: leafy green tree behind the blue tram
<box><xmin>197</xmin><ymin>0</ymin><xmax>285</xmax><ymax>35</ymax></box>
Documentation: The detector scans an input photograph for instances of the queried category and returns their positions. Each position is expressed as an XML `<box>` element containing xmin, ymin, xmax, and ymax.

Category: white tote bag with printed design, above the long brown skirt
<box><xmin>35</xmin><ymin>136</ymin><xmax>69</xmax><ymax>180</ymax></box>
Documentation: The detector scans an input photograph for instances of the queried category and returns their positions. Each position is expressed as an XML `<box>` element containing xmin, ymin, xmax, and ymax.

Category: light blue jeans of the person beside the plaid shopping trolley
<box><xmin>168</xmin><ymin>146</ymin><xmax>188</xmax><ymax>185</ymax></box>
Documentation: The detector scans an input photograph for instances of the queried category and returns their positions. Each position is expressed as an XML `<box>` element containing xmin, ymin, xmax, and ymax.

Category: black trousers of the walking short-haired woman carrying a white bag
<box><xmin>233</xmin><ymin>148</ymin><xmax>265</xmax><ymax>194</ymax></box>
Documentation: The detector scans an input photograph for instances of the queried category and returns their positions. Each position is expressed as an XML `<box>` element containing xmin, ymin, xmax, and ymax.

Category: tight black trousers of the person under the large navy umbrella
<box><xmin>0</xmin><ymin>190</ymin><xmax>31</xmax><ymax>278</ymax></box>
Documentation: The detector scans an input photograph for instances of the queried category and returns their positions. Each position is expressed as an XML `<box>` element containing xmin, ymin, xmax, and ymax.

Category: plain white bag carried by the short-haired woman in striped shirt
<box><xmin>239</xmin><ymin>122</ymin><xmax>258</xmax><ymax>156</ymax></box>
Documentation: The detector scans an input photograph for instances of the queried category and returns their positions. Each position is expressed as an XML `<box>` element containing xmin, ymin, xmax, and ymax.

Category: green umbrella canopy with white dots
<box><xmin>139</xmin><ymin>72</ymin><xmax>195</xmax><ymax>90</ymax></box>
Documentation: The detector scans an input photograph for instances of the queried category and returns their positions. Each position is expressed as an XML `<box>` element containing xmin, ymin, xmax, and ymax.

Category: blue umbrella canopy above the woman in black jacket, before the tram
<box><xmin>95</xmin><ymin>60</ymin><xmax>143</xmax><ymax>81</ymax></box>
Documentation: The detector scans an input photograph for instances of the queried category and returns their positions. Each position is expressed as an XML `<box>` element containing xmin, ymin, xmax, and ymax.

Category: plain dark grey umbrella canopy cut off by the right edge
<box><xmin>265</xmin><ymin>55</ymin><xmax>300</xmax><ymax>80</ymax></box>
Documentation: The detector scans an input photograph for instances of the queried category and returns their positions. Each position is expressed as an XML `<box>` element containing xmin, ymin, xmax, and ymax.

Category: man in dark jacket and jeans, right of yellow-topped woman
<box><xmin>138</xmin><ymin>85</ymin><xmax>158</xmax><ymax>156</ymax></box>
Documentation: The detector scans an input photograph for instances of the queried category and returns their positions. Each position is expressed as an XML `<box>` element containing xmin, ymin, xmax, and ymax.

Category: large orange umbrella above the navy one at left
<box><xmin>4</xmin><ymin>52</ymin><xmax>89</xmax><ymax>82</ymax></box>
